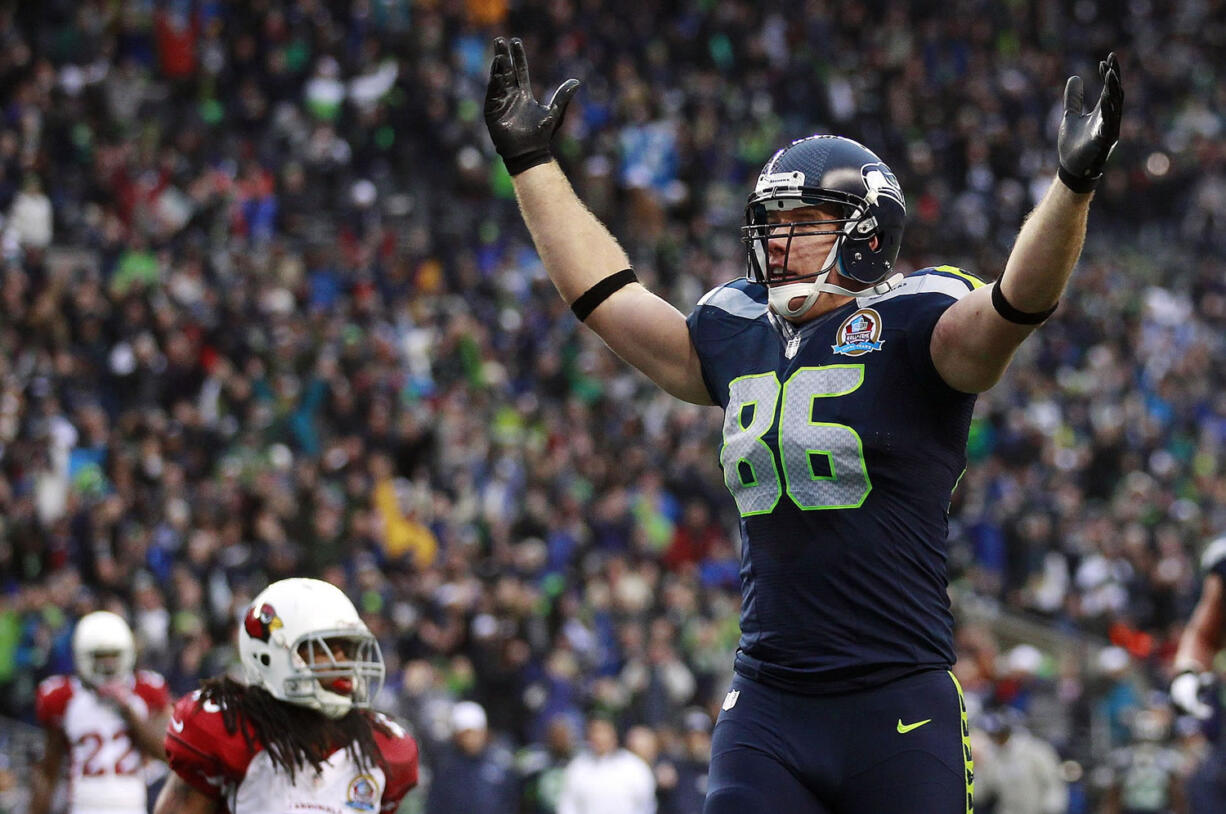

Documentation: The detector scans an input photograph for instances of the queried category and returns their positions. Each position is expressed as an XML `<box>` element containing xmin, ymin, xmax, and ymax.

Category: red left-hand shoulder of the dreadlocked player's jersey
<box><xmin>166</xmin><ymin>690</ymin><xmax>259</xmax><ymax>798</ymax></box>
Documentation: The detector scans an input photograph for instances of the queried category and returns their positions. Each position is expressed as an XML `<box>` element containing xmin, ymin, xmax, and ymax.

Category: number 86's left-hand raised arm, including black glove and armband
<box><xmin>485</xmin><ymin>38</ymin><xmax>711</xmax><ymax>405</ymax></box>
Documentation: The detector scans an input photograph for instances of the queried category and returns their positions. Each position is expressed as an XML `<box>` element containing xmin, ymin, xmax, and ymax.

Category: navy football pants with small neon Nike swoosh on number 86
<box><xmin>702</xmin><ymin>671</ymin><xmax>973</xmax><ymax>814</ymax></box>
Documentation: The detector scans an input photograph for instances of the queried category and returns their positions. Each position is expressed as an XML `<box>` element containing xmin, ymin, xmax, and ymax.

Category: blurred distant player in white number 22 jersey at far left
<box><xmin>29</xmin><ymin>611</ymin><xmax>170</xmax><ymax>814</ymax></box>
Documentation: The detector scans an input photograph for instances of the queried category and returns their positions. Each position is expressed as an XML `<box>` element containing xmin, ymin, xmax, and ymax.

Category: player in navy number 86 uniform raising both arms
<box><xmin>484</xmin><ymin>38</ymin><xmax>1124</xmax><ymax>814</ymax></box>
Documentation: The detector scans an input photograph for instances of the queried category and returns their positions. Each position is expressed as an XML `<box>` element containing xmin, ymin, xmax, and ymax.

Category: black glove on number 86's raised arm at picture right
<box><xmin>1058</xmin><ymin>51</ymin><xmax>1124</xmax><ymax>192</ymax></box>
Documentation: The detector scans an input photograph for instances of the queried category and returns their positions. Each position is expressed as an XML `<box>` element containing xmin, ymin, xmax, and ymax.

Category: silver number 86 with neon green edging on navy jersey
<box><xmin>720</xmin><ymin>364</ymin><xmax>873</xmax><ymax>517</ymax></box>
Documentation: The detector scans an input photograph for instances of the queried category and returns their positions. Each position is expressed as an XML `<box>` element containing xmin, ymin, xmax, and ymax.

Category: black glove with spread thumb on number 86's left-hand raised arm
<box><xmin>485</xmin><ymin>37</ymin><xmax>579</xmax><ymax>175</ymax></box>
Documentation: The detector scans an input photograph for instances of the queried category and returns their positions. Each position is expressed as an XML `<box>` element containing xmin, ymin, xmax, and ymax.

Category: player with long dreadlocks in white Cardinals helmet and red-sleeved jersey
<box><xmin>154</xmin><ymin>579</ymin><xmax>417</xmax><ymax>814</ymax></box>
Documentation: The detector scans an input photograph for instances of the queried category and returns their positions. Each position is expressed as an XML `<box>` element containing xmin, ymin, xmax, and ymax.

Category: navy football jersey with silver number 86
<box><xmin>687</xmin><ymin>266</ymin><xmax>982</xmax><ymax>693</ymax></box>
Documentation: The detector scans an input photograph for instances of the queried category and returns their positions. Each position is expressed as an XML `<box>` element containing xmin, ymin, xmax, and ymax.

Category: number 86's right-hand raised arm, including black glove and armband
<box><xmin>932</xmin><ymin>54</ymin><xmax>1124</xmax><ymax>392</ymax></box>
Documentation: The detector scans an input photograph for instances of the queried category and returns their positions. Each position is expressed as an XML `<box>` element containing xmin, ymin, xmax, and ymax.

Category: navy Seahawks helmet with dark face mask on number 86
<box><xmin>742</xmin><ymin>136</ymin><xmax>907</xmax><ymax>318</ymax></box>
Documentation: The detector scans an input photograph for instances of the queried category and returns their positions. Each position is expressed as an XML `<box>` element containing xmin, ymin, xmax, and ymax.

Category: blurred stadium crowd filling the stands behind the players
<box><xmin>0</xmin><ymin>0</ymin><xmax>1226</xmax><ymax>812</ymax></box>
